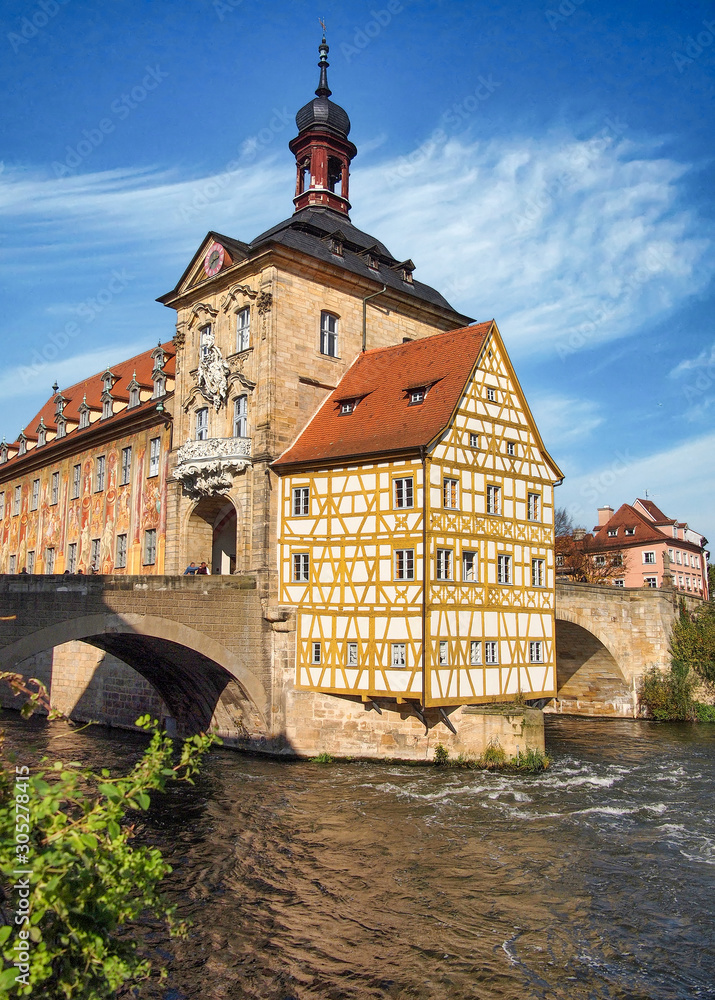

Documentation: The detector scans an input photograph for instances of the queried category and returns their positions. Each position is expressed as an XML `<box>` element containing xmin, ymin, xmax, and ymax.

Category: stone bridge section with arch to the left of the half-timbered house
<box><xmin>0</xmin><ymin>576</ymin><xmax>292</xmax><ymax>742</ymax></box>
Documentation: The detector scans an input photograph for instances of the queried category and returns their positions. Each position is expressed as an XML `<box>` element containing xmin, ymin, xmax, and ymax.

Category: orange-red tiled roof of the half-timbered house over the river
<box><xmin>273</xmin><ymin>320</ymin><xmax>493</xmax><ymax>468</ymax></box>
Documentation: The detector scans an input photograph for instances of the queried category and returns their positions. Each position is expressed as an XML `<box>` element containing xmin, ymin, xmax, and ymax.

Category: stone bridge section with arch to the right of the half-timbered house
<box><xmin>544</xmin><ymin>583</ymin><xmax>702</xmax><ymax>717</ymax></box>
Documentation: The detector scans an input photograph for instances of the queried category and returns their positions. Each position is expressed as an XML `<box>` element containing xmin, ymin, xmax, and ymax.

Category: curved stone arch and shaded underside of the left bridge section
<box><xmin>0</xmin><ymin>613</ymin><xmax>270</xmax><ymax>735</ymax></box>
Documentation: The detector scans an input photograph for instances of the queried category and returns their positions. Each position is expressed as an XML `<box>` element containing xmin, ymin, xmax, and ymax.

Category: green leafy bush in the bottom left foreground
<box><xmin>0</xmin><ymin>673</ymin><xmax>218</xmax><ymax>1000</ymax></box>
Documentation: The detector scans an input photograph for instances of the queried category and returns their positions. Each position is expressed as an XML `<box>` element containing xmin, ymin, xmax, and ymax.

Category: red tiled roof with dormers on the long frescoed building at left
<box><xmin>3</xmin><ymin>341</ymin><xmax>176</xmax><ymax>469</ymax></box>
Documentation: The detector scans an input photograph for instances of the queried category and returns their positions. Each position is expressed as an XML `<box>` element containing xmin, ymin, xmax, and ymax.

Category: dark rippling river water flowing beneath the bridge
<box><xmin>3</xmin><ymin>712</ymin><xmax>715</xmax><ymax>1000</ymax></box>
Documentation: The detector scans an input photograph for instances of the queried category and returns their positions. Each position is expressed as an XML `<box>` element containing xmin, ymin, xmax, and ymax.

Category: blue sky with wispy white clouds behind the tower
<box><xmin>0</xmin><ymin>0</ymin><xmax>715</xmax><ymax>543</ymax></box>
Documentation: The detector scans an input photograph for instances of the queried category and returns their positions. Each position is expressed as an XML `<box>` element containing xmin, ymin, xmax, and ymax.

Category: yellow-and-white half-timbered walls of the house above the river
<box><xmin>279</xmin><ymin>324</ymin><xmax>561</xmax><ymax>706</ymax></box>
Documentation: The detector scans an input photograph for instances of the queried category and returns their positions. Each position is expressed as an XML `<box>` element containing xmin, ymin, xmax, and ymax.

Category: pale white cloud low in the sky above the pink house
<box><xmin>556</xmin><ymin>432</ymin><xmax>715</xmax><ymax>547</ymax></box>
